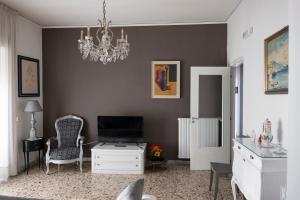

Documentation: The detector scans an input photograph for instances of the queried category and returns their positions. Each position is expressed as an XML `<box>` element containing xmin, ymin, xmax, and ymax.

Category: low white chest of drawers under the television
<box><xmin>91</xmin><ymin>143</ymin><xmax>146</xmax><ymax>174</ymax></box>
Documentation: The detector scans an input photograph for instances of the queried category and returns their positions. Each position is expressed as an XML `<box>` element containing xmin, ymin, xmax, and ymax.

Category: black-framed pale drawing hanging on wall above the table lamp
<box><xmin>18</xmin><ymin>55</ymin><xmax>40</xmax><ymax>97</ymax></box>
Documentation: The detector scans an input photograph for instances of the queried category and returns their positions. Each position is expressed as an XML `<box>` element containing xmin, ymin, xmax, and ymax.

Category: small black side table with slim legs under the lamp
<box><xmin>23</xmin><ymin>138</ymin><xmax>44</xmax><ymax>174</ymax></box>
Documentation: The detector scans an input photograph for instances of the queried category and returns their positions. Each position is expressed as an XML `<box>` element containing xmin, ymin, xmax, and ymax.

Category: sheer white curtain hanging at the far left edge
<box><xmin>0</xmin><ymin>3</ymin><xmax>18</xmax><ymax>181</ymax></box>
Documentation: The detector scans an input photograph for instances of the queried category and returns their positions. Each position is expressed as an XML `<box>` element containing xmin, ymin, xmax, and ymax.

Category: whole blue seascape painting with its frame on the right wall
<box><xmin>265</xmin><ymin>27</ymin><xmax>289</xmax><ymax>94</ymax></box>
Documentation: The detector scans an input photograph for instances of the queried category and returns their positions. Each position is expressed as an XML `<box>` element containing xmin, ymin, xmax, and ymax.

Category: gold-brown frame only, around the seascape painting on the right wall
<box><xmin>264</xmin><ymin>26</ymin><xmax>289</xmax><ymax>95</ymax></box>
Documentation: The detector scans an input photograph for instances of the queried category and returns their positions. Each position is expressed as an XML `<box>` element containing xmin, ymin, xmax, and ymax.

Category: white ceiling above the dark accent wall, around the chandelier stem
<box><xmin>0</xmin><ymin>0</ymin><xmax>241</xmax><ymax>27</ymax></box>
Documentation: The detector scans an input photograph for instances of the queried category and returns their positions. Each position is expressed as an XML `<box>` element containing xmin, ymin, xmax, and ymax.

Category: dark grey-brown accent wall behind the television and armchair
<box><xmin>43</xmin><ymin>24</ymin><xmax>227</xmax><ymax>159</ymax></box>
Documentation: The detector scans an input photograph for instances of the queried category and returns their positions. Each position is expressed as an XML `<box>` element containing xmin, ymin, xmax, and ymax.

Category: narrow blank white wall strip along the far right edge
<box><xmin>287</xmin><ymin>0</ymin><xmax>300</xmax><ymax>200</ymax></box>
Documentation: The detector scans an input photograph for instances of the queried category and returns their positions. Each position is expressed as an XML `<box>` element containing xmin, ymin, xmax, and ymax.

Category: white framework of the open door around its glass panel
<box><xmin>190</xmin><ymin>66</ymin><xmax>231</xmax><ymax>170</ymax></box>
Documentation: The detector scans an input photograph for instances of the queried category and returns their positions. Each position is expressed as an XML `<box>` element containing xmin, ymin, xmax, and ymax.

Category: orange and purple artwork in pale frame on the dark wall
<box><xmin>151</xmin><ymin>61</ymin><xmax>180</xmax><ymax>99</ymax></box>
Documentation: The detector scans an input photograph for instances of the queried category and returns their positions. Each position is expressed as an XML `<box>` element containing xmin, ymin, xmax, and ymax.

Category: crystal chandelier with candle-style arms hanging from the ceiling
<box><xmin>78</xmin><ymin>0</ymin><xmax>129</xmax><ymax>64</ymax></box>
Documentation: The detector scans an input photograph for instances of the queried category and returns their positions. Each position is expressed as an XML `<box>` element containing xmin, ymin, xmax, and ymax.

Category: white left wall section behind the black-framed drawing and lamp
<box><xmin>16</xmin><ymin>16</ymin><xmax>43</xmax><ymax>170</ymax></box>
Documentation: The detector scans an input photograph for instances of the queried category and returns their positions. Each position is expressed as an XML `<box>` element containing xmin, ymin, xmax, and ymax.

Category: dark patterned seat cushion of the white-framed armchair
<box><xmin>50</xmin><ymin>147</ymin><xmax>80</xmax><ymax>160</ymax></box>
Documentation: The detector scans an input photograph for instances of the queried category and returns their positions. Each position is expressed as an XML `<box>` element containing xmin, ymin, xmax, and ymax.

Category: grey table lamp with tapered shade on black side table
<box><xmin>24</xmin><ymin>100</ymin><xmax>42</xmax><ymax>140</ymax></box>
